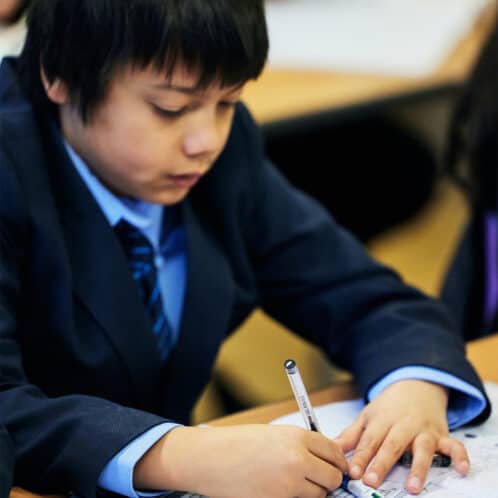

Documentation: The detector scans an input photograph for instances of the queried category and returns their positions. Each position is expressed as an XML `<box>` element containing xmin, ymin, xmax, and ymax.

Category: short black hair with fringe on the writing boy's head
<box><xmin>20</xmin><ymin>0</ymin><xmax>268</xmax><ymax>120</ymax></box>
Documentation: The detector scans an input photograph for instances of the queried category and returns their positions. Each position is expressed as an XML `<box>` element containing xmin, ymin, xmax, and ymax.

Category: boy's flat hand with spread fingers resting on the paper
<box><xmin>335</xmin><ymin>380</ymin><xmax>470</xmax><ymax>494</ymax></box>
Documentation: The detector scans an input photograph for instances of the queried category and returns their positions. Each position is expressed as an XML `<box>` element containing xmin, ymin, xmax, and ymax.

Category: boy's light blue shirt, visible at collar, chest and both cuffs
<box><xmin>66</xmin><ymin>143</ymin><xmax>486</xmax><ymax>498</ymax></box>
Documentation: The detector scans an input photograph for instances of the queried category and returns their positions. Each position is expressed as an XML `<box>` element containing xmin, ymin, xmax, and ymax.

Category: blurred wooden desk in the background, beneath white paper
<box><xmin>244</xmin><ymin>7</ymin><xmax>496</xmax><ymax>124</ymax></box>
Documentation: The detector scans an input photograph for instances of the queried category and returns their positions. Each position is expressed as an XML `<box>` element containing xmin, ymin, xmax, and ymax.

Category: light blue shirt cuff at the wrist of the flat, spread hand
<box><xmin>367</xmin><ymin>367</ymin><xmax>486</xmax><ymax>430</ymax></box>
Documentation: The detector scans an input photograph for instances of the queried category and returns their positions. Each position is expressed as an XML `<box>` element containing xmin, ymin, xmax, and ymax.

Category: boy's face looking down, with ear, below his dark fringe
<box><xmin>46</xmin><ymin>64</ymin><xmax>243</xmax><ymax>205</ymax></box>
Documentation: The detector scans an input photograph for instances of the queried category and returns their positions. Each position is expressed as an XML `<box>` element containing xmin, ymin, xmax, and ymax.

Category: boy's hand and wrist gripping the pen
<box><xmin>134</xmin><ymin>425</ymin><xmax>348</xmax><ymax>498</ymax></box>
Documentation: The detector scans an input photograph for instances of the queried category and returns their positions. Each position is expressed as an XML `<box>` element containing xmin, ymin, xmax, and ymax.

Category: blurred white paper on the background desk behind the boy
<box><xmin>266</xmin><ymin>0</ymin><xmax>490</xmax><ymax>76</ymax></box>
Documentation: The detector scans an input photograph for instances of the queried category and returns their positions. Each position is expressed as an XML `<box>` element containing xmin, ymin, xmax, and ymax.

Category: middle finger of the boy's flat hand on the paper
<box><xmin>364</xmin><ymin>424</ymin><xmax>413</xmax><ymax>487</ymax></box>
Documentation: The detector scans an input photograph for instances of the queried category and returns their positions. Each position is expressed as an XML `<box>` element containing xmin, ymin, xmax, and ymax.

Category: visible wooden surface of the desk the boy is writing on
<box><xmin>10</xmin><ymin>334</ymin><xmax>498</xmax><ymax>498</ymax></box>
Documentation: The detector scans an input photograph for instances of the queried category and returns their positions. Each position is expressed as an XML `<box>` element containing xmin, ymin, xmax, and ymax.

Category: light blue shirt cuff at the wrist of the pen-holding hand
<box><xmin>98</xmin><ymin>423</ymin><xmax>178</xmax><ymax>498</ymax></box>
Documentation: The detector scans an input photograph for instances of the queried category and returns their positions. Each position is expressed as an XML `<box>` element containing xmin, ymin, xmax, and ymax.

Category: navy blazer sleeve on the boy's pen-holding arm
<box><xmin>0</xmin><ymin>150</ymin><xmax>164</xmax><ymax>497</ymax></box>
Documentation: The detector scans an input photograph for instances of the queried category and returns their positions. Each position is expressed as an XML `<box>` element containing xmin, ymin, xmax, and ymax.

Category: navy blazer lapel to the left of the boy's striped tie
<box><xmin>45</xmin><ymin>129</ymin><xmax>160</xmax><ymax>410</ymax></box>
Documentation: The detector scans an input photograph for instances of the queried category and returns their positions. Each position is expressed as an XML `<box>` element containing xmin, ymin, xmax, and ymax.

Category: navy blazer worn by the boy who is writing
<box><xmin>0</xmin><ymin>60</ymin><xmax>487</xmax><ymax>497</ymax></box>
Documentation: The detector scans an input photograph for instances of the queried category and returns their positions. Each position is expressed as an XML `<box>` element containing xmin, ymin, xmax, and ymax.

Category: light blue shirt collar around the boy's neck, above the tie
<box><xmin>64</xmin><ymin>140</ymin><xmax>164</xmax><ymax>248</ymax></box>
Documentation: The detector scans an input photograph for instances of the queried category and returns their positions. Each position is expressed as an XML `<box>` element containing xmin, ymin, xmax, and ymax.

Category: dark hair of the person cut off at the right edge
<box><xmin>446</xmin><ymin>24</ymin><xmax>498</xmax><ymax>211</ymax></box>
